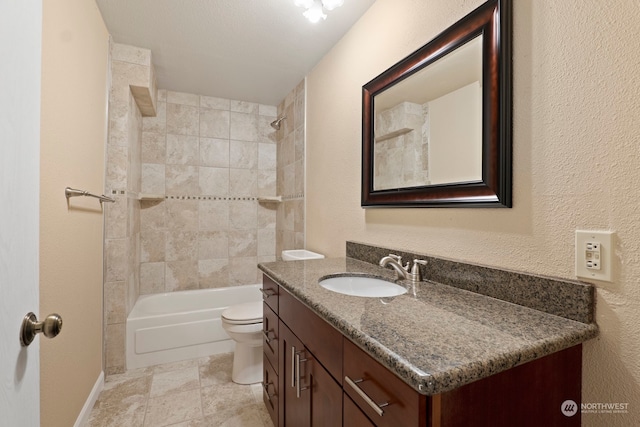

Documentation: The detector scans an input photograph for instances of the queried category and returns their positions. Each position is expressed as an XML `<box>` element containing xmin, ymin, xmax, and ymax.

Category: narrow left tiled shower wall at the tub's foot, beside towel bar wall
<box><xmin>104</xmin><ymin>44</ymin><xmax>155</xmax><ymax>375</ymax></box>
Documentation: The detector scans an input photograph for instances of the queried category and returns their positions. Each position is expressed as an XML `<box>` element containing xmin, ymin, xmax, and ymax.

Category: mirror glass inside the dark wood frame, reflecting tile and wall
<box><xmin>373</xmin><ymin>35</ymin><xmax>483</xmax><ymax>191</ymax></box>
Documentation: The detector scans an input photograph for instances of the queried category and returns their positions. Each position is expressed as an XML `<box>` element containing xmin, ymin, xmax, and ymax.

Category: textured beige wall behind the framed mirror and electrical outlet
<box><xmin>307</xmin><ymin>0</ymin><xmax>640</xmax><ymax>426</ymax></box>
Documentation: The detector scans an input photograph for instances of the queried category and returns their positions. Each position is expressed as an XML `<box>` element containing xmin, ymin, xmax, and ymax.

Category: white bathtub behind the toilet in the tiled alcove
<box><xmin>126</xmin><ymin>285</ymin><xmax>262</xmax><ymax>369</ymax></box>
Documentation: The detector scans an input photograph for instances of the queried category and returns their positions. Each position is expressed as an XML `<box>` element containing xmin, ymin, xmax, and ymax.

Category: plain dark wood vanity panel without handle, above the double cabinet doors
<box><xmin>279</xmin><ymin>288</ymin><xmax>342</xmax><ymax>384</ymax></box>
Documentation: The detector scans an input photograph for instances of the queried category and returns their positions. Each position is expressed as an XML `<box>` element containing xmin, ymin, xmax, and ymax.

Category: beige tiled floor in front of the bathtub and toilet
<box><xmin>88</xmin><ymin>353</ymin><xmax>273</xmax><ymax>427</ymax></box>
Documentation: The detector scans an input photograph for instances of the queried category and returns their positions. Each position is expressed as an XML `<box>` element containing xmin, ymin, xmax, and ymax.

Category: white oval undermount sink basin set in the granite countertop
<box><xmin>319</xmin><ymin>276</ymin><xmax>407</xmax><ymax>298</ymax></box>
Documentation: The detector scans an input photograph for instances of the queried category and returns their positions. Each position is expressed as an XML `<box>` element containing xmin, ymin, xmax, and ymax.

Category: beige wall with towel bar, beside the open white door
<box><xmin>39</xmin><ymin>0</ymin><xmax>109</xmax><ymax>427</ymax></box>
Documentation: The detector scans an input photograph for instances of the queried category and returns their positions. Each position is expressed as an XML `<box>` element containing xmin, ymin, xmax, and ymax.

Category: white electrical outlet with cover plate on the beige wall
<box><xmin>576</xmin><ymin>230</ymin><xmax>614</xmax><ymax>282</ymax></box>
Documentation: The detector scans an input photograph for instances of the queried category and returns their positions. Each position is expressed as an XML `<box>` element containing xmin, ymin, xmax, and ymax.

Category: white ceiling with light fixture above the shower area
<box><xmin>96</xmin><ymin>0</ymin><xmax>375</xmax><ymax>105</ymax></box>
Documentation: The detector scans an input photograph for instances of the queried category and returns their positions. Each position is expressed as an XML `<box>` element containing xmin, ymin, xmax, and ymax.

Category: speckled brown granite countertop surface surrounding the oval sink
<box><xmin>259</xmin><ymin>258</ymin><xmax>598</xmax><ymax>395</ymax></box>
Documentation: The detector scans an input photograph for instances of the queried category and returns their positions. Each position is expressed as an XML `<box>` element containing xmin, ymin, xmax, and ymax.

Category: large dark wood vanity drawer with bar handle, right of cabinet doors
<box><xmin>342</xmin><ymin>338</ymin><xmax>427</xmax><ymax>427</ymax></box>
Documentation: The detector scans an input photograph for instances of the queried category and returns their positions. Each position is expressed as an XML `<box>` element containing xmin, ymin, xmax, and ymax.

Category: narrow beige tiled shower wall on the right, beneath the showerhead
<box><xmin>276</xmin><ymin>80</ymin><xmax>306</xmax><ymax>256</ymax></box>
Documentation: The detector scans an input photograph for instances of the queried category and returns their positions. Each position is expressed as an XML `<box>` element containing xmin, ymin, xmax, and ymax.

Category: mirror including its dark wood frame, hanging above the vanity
<box><xmin>361</xmin><ymin>0</ymin><xmax>512</xmax><ymax>208</ymax></box>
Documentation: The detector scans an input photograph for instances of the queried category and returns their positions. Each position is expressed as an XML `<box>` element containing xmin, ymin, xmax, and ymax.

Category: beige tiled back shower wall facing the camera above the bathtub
<box><xmin>140</xmin><ymin>90</ymin><xmax>277</xmax><ymax>294</ymax></box>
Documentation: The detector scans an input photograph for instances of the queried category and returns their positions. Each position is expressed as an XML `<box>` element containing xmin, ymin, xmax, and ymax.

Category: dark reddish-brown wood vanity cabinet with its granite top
<box><xmin>260</xmin><ymin>258</ymin><xmax>597</xmax><ymax>427</ymax></box>
